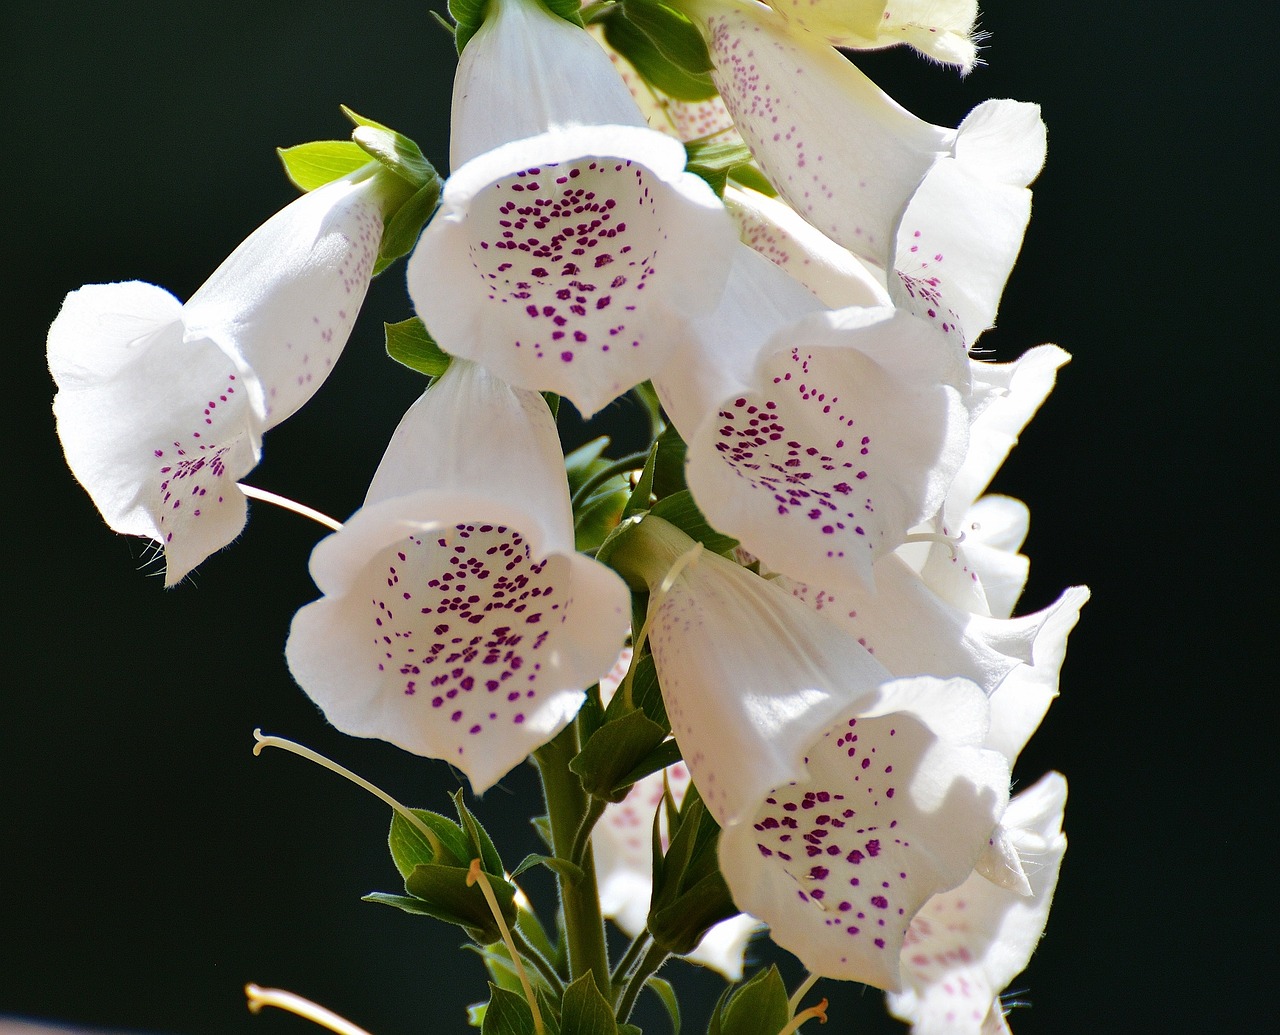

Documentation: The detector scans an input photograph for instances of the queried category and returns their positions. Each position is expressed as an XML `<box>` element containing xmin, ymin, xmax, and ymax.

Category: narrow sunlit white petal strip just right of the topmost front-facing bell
<box><xmin>724</xmin><ymin>184</ymin><xmax>890</xmax><ymax>310</ymax></box>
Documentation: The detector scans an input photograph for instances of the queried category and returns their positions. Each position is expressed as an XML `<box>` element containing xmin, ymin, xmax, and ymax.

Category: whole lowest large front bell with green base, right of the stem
<box><xmin>612</xmin><ymin>518</ymin><xmax>1009</xmax><ymax>989</ymax></box>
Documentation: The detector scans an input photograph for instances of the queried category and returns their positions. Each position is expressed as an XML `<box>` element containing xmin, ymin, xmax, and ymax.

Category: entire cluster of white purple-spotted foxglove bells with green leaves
<box><xmin>49</xmin><ymin>0</ymin><xmax>1088</xmax><ymax>1032</ymax></box>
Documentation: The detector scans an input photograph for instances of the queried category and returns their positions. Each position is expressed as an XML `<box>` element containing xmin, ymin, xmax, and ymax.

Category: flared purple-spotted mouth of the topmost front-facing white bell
<box><xmin>408</xmin><ymin>127</ymin><xmax>737</xmax><ymax>415</ymax></box>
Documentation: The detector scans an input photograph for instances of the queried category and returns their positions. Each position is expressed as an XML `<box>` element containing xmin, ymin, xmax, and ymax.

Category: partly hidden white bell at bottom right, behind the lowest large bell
<box><xmin>888</xmin><ymin>773</ymin><xmax>1066</xmax><ymax>1035</ymax></box>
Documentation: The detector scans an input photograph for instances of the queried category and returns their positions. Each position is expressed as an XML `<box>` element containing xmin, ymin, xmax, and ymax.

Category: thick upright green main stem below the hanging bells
<box><xmin>534</xmin><ymin>723</ymin><xmax>609</xmax><ymax>989</ymax></box>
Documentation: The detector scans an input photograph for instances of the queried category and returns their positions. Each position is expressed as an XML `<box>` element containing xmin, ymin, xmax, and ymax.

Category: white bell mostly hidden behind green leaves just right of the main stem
<box><xmin>591</xmin><ymin>647</ymin><xmax>760</xmax><ymax>981</ymax></box>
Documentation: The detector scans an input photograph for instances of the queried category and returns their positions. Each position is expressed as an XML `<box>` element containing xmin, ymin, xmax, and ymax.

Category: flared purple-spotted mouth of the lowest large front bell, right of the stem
<box><xmin>721</xmin><ymin>678</ymin><xmax>1009</xmax><ymax>989</ymax></box>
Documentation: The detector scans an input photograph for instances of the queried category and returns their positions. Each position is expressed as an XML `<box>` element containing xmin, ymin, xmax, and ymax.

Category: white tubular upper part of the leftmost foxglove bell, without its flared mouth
<box><xmin>183</xmin><ymin>169</ymin><xmax>383</xmax><ymax>430</ymax></box>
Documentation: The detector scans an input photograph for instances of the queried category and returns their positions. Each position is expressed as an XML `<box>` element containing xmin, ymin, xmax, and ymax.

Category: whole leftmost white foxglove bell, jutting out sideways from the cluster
<box><xmin>49</xmin><ymin>164</ymin><xmax>388</xmax><ymax>586</ymax></box>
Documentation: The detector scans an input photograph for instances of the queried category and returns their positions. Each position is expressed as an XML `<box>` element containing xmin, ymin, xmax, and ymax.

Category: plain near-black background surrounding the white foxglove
<box><xmin>0</xmin><ymin>0</ymin><xmax>1276</xmax><ymax>1035</ymax></box>
